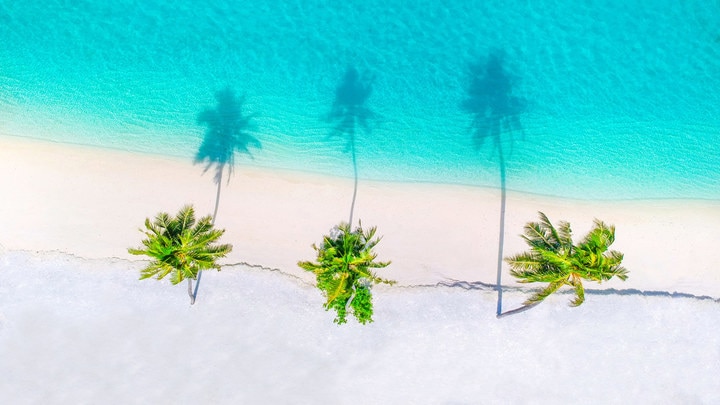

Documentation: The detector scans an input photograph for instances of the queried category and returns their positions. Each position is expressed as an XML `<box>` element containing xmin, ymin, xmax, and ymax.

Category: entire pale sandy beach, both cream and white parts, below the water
<box><xmin>0</xmin><ymin>136</ymin><xmax>720</xmax><ymax>404</ymax></box>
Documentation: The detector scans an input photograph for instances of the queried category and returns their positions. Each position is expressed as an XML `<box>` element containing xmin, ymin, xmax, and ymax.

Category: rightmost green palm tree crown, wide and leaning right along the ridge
<box><xmin>505</xmin><ymin>212</ymin><xmax>628</xmax><ymax>306</ymax></box>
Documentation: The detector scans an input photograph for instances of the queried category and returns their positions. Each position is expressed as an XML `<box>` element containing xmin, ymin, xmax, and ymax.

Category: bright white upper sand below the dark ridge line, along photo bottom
<box><xmin>0</xmin><ymin>252</ymin><xmax>720</xmax><ymax>404</ymax></box>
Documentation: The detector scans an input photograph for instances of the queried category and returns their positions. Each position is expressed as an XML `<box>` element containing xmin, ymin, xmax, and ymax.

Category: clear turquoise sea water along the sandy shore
<box><xmin>0</xmin><ymin>0</ymin><xmax>720</xmax><ymax>200</ymax></box>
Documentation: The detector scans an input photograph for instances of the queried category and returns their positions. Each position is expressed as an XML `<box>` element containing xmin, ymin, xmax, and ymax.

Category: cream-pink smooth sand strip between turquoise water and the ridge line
<box><xmin>0</xmin><ymin>136</ymin><xmax>720</xmax><ymax>297</ymax></box>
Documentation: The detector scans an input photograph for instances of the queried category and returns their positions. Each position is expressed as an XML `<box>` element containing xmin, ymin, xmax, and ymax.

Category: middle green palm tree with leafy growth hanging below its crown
<box><xmin>298</xmin><ymin>223</ymin><xmax>395</xmax><ymax>324</ymax></box>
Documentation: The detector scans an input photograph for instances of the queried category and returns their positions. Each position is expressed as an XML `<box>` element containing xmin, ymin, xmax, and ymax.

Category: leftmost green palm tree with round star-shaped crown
<box><xmin>128</xmin><ymin>205</ymin><xmax>232</xmax><ymax>305</ymax></box>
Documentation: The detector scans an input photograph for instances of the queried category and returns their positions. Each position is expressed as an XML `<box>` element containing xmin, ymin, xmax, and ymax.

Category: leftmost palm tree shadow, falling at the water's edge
<box><xmin>194</xmin><ymin>87</ymin><xmax>261</xmax><ymax>223</ymax></box>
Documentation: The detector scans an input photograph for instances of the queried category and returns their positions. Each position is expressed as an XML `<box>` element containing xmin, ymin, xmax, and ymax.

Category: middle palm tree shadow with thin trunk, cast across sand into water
<box><xmin>325</xmin><ymin>66</ymin><xmax>377</xmax><ymax>227</ymax></box>
